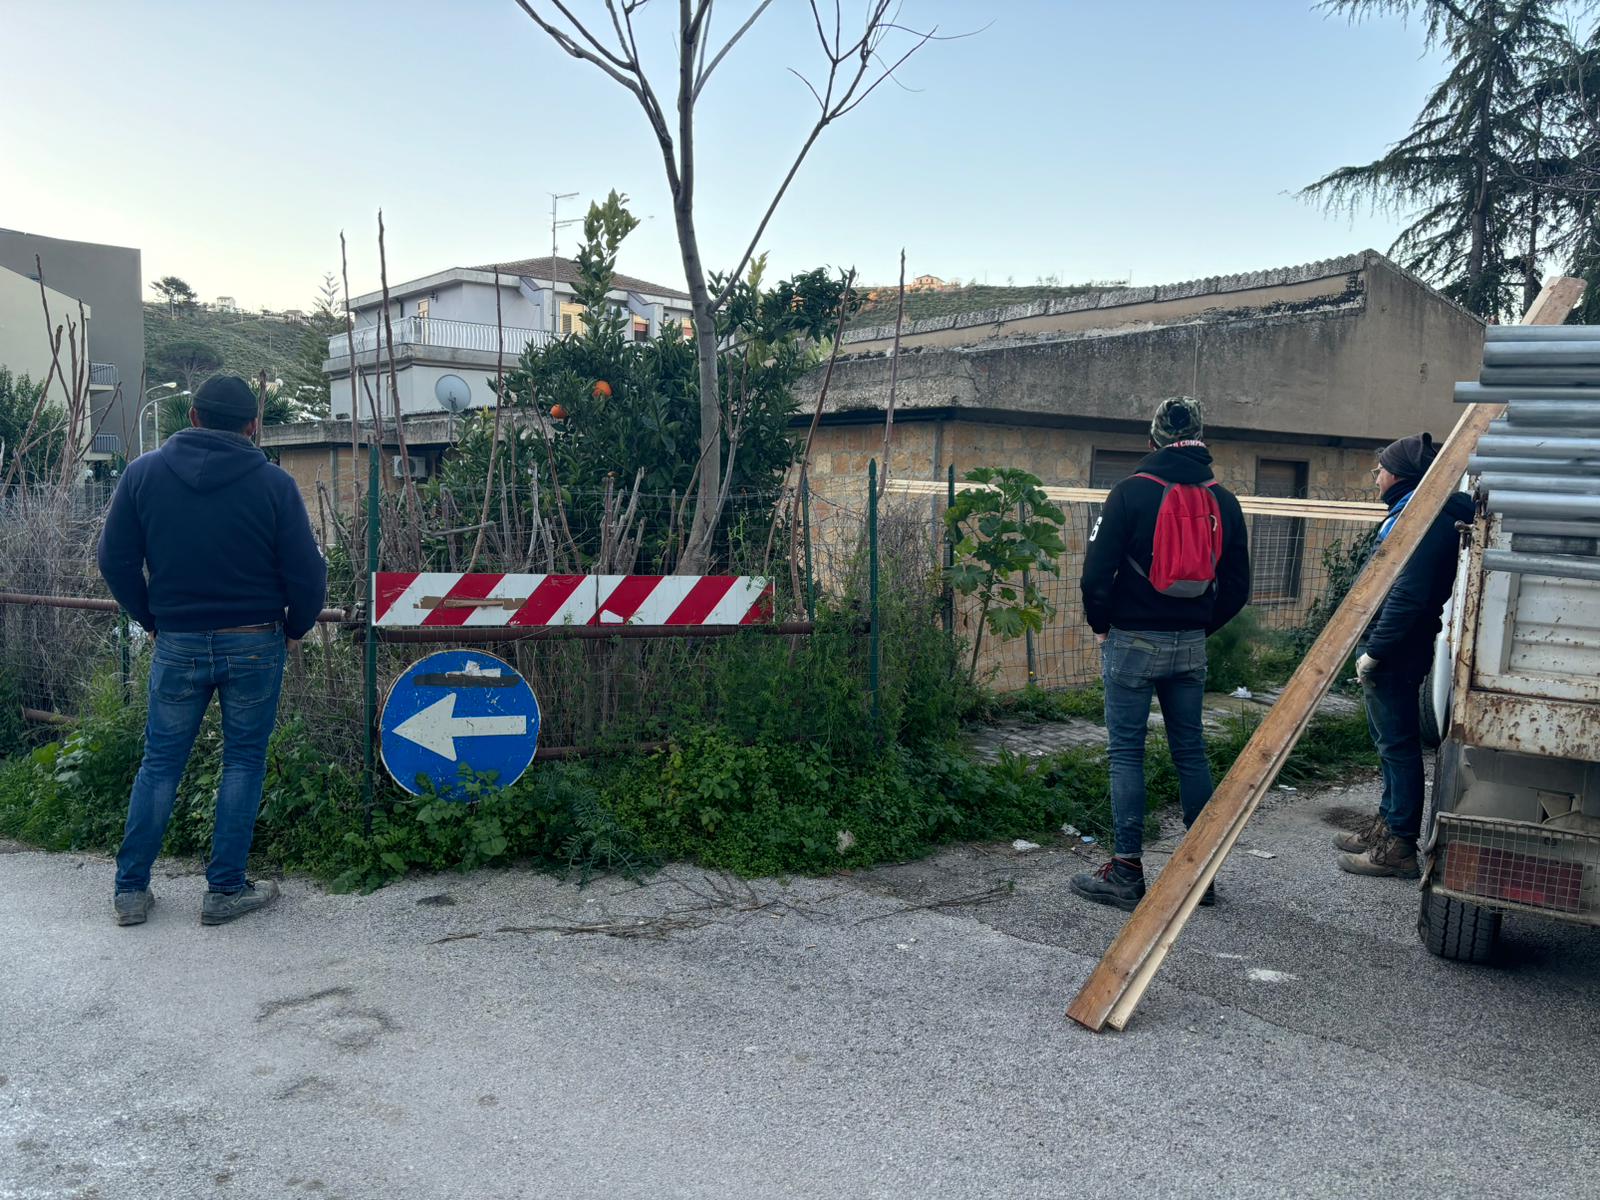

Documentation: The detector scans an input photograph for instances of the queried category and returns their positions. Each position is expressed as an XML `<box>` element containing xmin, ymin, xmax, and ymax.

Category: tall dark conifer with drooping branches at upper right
<box><xmin>1302</xmin><ymin>0</ymin><xmax>1570</xmax><ymax>317</ymax></box>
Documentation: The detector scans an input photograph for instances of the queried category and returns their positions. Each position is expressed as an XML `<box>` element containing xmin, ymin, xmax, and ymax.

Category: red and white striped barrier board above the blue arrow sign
<box><xmin>371</xmin><ymin>571</ymin><xmax>773</xmax><ymax>629</ymax></box>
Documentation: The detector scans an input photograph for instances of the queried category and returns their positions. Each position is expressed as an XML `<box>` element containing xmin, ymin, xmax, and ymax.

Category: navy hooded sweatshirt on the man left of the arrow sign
<box><xmin>99</xmin><ymin>429</ymin><xmax>328</xmax><ymax>638</ymax></box>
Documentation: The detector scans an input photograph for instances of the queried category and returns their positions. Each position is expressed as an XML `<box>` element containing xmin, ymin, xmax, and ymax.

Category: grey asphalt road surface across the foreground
<box><xmin>0</xmin><ymin>774</ymin><xmax>1600</xmax><ymax>1200</ymax></box>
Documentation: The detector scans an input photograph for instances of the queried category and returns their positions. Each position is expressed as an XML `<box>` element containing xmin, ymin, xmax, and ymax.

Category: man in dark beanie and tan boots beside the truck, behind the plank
<box><xmin>1334</xmin><ymin>434</ymin><xmax>1472</xmax><ymax>878</ymax></box>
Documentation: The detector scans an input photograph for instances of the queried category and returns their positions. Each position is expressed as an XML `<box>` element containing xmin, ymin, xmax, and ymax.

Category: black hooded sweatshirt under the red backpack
<box><xmin>1082</xmin><ymin>445</ymin><xmax>1250</xmax><ymax>634</ymax></box>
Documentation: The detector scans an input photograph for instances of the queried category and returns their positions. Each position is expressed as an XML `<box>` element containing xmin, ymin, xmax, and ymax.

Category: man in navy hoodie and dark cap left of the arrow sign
<box><xmin>99</xmin><ymin>374</ymin><xmax>328</xmax><ymax>925</ymax></box>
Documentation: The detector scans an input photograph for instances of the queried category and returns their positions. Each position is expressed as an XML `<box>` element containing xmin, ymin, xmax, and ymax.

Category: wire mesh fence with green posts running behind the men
<box><xmin>0</xmin><ymin>464</ymin><xmax>1378</xmax><ymax>768</ymax></box>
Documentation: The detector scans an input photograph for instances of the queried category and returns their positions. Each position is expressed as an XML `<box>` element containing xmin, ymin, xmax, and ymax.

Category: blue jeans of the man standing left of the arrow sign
<box><xmin>117</xmin><ymin>629</ymin><xmax>285</xmax><ymax>891</ymax></box>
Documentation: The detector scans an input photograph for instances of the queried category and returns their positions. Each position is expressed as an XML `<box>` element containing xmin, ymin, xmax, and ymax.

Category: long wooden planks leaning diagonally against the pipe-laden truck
<box><xmin>1067</xmin><ymin>278</ymin><xmax>1582</xmax><ymax>1030</ymax></box>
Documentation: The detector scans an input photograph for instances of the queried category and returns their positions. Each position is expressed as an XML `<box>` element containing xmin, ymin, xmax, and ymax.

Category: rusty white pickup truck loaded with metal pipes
<box><xmin>1418</xmin><ymin>326</ymin><xmax>1600</xmax><ymax>963</ymax></box>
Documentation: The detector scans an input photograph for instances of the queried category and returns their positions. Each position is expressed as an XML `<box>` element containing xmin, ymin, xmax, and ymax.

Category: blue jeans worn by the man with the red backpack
<box><xmin>1101</xmin><ymin>629</ymin><xmax>1211</xmax><ymax>858</ymax></box>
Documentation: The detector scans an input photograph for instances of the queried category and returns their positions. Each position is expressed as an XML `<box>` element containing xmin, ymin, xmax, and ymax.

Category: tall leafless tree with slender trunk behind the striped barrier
<box><xmin>517</xmin><ymin>0</ymin><xmax>936</xmax><ymax>574</ymax></box>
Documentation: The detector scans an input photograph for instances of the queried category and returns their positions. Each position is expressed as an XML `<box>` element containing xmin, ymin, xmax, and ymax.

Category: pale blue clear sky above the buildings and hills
<box><xmin>0</xmin><ymin>0</ymin><xmax>1440</xmax><ymax>307</ymax></box>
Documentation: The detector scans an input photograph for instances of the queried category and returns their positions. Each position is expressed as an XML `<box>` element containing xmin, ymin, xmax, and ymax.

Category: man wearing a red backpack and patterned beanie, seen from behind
<box><xmin>1072</xmin><ymin>395</ymin><xmax>1250</xmax><ymax>912</ymax></box>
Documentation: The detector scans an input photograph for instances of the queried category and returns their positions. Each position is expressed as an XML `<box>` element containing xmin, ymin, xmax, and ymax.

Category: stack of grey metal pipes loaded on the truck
<box><xmin>1456</xmin><ymin>325</ymin><xmax>1600</xmax><ymax>579</ymax></box>
